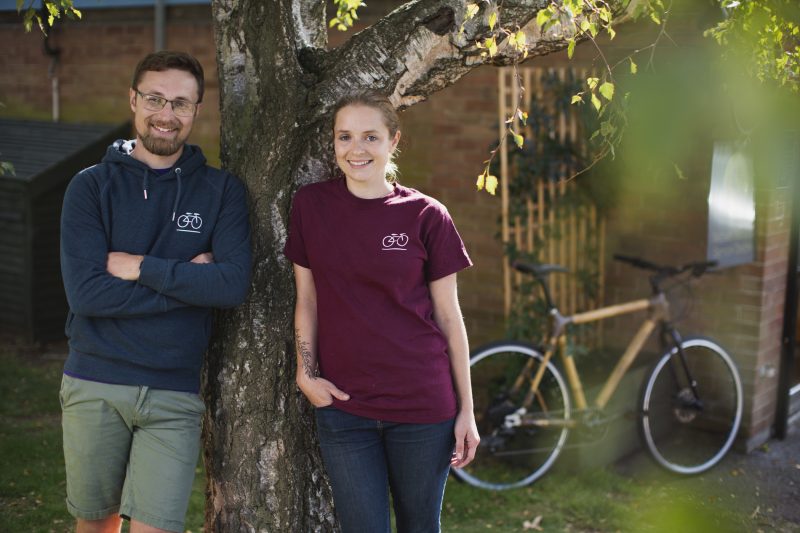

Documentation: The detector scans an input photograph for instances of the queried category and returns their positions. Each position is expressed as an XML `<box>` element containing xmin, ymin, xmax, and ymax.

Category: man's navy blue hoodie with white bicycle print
<box><xmin>61</xmin><ymin>140</ymin><xmax>251</xmax><ymax>391</ymax></box>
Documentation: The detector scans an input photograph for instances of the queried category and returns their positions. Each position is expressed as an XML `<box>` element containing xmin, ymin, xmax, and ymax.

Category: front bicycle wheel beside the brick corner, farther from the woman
<box><xmin>639</xmin><ymin>338</ymin><xmax>742</xmax><ymax>474</ymax></box>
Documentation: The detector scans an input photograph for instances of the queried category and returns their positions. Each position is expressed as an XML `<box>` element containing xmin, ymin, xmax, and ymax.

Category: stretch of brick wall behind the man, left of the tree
<box><xmin>0</xmin><ymin>6</ymin><xmax>219</xmax><ymax>164</ymax></box>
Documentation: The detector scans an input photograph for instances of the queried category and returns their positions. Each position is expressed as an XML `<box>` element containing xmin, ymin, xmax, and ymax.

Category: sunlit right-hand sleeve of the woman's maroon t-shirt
<box><xmin>422</xmin><ymin>202</ymin><xmax>472</xmax><ymax>283</ymax></box>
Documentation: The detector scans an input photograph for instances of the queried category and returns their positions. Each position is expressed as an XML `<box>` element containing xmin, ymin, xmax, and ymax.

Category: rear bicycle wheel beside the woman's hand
<box><xmin>454</xmin><ymin>342</ymin><xmax>570</xmax><ymax>490</ymax></box>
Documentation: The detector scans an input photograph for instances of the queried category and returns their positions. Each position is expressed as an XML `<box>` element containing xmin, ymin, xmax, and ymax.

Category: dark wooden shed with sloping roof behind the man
<box><xmin>0</xmin><ymin>119</ymin><xmax>131</xmax><ymax>342</ymax></box>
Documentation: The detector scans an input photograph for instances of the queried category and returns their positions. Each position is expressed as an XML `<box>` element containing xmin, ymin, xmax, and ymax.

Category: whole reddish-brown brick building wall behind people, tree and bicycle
<box><xmin>0</xmin><ymin>0</ymin><xmax>791</xmax><ymax>438</ymax></box>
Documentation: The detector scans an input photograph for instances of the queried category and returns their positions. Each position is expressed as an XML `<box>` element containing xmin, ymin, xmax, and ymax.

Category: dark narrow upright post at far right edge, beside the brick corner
<box><xmin>775</xmin><ymin>132</ymin><xmax>800</xmax><ymax>439</ymax></box>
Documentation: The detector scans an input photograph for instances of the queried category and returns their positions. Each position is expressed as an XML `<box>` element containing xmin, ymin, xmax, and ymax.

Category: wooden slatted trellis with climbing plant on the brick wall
<box><xmin>498</xmin><ymin>67</ymin><xmax>605</xmax><ymax>346</ymax></box>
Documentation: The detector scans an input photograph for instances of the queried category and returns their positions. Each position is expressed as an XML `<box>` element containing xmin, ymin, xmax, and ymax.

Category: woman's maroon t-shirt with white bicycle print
<box><xmin>284</xmin><ymin>178</ymin><xmax>472</xmax><ymax>423</ymax></box>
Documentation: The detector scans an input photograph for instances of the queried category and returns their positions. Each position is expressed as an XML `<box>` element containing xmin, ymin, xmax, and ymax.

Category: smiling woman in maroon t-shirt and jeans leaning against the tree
<box><xmin>284</xmin><ymin>92</ymin><xmax>479</xmax><ymax>533</ymax></box>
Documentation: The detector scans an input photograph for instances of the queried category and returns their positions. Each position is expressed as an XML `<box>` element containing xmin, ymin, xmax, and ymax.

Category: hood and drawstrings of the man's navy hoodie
<box><xmin>103</xmin><ymin>139</ymin><xmax>206</xmax><ymax>221</ymax></box>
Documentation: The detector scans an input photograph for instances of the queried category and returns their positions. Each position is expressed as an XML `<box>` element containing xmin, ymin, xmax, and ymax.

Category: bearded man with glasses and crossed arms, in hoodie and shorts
<box><xmin>61</xmin><ymin>52</ymin><xmax>251</xmax><ymax>533</ymax></box>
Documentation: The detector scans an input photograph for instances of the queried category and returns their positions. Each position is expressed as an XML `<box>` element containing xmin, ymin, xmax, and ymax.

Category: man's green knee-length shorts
<box><xmin>60</xmin><ymin>375</ymin><xmax>205</xmax><ymax>531</ymax></box>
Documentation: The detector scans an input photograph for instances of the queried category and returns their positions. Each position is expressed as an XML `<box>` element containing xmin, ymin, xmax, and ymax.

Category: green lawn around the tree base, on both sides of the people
<box><xmin>0</xmin><ymin>346</ymin><xmax>788</xmax><ymax>533</ymax></box>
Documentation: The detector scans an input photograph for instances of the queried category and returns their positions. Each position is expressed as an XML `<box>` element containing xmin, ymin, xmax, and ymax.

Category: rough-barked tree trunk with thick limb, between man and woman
<box><xmin>204</xmin><ymin>0</ymin><xmax>604</xmax><ymax>532</ymax></box>
